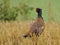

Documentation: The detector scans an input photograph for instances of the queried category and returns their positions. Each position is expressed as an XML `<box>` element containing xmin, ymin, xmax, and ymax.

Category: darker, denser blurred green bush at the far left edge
<box><xmin>0</xmin><ymin>0</ymin><xmax>17</xmax><ymax>21</ymax></box>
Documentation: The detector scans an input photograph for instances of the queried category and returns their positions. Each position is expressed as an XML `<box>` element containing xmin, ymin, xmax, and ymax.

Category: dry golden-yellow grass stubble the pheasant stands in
<box><xmin>0</xmin><ymin>21</ymin><xmax>60</xmax><ymax>45</ymax></box>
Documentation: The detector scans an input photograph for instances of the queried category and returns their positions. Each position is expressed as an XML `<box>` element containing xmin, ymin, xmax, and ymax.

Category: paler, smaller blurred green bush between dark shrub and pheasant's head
<box><xmin>19</xmin><ymin>3</ymin><xmax>33</xmax><ymax>20</ymax></box>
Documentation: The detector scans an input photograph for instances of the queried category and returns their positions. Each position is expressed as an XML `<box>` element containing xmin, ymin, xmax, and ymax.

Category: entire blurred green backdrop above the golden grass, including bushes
<box><xmin>0</xmin><ymin>0</ymin><xmax>60</xmax><ymax>22</ymax></box>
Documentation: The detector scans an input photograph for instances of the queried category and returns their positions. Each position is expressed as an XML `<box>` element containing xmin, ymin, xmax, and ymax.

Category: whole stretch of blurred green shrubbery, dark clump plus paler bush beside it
<box><xmin>0</xmin><ymin>0</ymin><xmax>33</xmax><ymax>21</ymax></box>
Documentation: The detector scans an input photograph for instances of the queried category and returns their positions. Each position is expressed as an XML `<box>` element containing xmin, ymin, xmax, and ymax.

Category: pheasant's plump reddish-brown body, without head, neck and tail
<box><xmin>29</xmin><ymin>18</ymin><xmax>44</xmax><ymax>35</ymax></box>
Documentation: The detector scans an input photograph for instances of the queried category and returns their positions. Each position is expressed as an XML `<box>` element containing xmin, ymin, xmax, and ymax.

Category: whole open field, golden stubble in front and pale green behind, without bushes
<box><xmin>0</xmin><ymin>0</ymin><xmax>60</xmax><ymax>45</ymax></box>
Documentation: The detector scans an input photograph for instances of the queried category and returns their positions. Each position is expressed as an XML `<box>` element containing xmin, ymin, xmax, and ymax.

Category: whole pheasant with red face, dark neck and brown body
<box><xmin>24</xmin><ymin>8</ymin><xmax>45</xmax><ymax>38</ymax></box>
